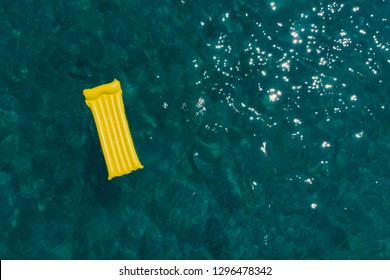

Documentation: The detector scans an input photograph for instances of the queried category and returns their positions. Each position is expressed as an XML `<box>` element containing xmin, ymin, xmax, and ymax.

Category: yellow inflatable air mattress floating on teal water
<box><xmin>83</xmin><ymin>79</ymin><xmax>143</xmax><ymax>180</ymax></box>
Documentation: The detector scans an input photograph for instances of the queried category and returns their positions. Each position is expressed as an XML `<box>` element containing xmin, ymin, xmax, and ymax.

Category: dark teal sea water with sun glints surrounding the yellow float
<box><xmin>0</xmin><ymin>0</ymin><xmax>390</xmax><ymax>259</ymax></box>
